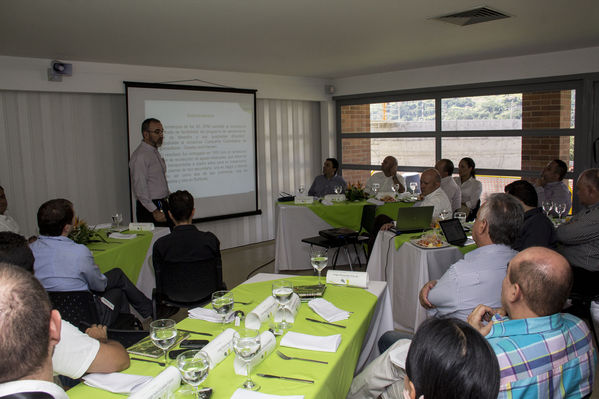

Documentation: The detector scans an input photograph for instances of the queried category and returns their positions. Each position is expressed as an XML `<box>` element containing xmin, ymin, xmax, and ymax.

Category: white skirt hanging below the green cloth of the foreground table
<box><xmin>242</xmin><ymin>273</ymin><xmax>393</xmax><ymax>375</ymax></box>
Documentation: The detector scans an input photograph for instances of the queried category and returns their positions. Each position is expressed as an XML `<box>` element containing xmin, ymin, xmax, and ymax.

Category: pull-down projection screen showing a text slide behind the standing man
<box><xmin>126</xmin><ymin>82</ymin><xmax>258</xmax><ymax>219</ymax></box>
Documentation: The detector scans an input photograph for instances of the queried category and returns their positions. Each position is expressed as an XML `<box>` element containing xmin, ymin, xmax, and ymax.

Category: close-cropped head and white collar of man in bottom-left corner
<box><xmin>0</xmin><ymin>263</ymin><xmax>68</xmax><ymax>399</ymax></box>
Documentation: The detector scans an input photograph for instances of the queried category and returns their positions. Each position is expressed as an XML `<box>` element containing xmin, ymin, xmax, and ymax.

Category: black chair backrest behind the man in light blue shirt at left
<box><xmin>48</xmin><ymin>291</ymin><xmax>100</xmax><ymax>329</ymax></box>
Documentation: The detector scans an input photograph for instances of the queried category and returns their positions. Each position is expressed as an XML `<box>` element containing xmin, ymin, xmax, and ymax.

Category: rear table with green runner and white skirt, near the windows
<box><xmin>275</xmin><ymin>201</ymin><xmax>414</xmax><ymax>273</ymax></box>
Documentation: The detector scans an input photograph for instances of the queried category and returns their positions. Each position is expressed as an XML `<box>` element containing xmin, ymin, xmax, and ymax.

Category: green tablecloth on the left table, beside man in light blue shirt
<box><xmin>87</xmin><ymin>230</ymin><xmax>152</xmax><ymax>284</ymax></box>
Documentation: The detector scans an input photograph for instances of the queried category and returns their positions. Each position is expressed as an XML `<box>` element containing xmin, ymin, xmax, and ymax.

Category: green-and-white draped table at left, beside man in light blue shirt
<box><xmin>87</xmin><ymin>227</ymin><xmax>170</xmax><ymax>298</ymax></box>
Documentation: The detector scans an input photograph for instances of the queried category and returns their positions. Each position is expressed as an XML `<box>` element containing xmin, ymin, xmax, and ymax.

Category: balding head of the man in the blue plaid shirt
<box><xmin>508</xmin><ymin>247</ymin><xmax>572</xmax><ymax>316</ymax></box>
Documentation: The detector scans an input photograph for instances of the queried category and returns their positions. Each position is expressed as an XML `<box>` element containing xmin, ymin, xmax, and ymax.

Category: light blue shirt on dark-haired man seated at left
<box><xmin>30</xmin><ymin>236</ymin><xmax>107</xmax><ymax>291</ymax></box>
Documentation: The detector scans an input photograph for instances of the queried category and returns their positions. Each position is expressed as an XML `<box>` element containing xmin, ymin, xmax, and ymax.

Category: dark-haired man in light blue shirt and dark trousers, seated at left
<box><xmin>31</xmin><ymin>199</ymin><xmax>152</xmax><ymax>326</ymax></box>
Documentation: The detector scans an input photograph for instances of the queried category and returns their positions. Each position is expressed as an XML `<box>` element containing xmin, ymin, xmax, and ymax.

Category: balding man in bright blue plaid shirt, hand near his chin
<box><xmin>468</xmin><ymin>247</ymin><xmax>597</xmax><ymax>398</ymax></box>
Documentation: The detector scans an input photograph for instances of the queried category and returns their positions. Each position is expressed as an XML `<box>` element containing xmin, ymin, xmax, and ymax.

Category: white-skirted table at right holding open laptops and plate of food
<box><xmin>366</xmin><ymin>231</ymin><xmax>476</xmax><ymax>333</ymax></box>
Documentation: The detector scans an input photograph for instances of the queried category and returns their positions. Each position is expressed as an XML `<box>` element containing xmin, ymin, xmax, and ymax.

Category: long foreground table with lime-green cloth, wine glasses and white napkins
<box><xmin>67</xmin><ymin>273</ymin><xmax>392</xmax><ymax>399</ymax></box>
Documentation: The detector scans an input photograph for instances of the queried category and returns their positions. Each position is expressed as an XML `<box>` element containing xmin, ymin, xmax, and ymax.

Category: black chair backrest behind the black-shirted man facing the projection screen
<box><xmin>152</xmin><ymin>257</ymin><xmax>224</xmax><ymax>318</ymax></box>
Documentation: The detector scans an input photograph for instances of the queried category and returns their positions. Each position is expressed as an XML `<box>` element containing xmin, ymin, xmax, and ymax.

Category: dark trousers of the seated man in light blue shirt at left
<box><xmin>96</xmin><ymin>268</ymin><xmax>152</xmax><ymax>326</ymax></box>
